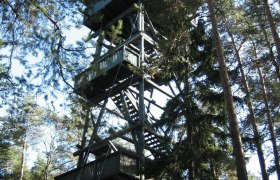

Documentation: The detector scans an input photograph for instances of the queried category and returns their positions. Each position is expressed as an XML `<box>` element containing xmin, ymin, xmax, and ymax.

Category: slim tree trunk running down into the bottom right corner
<box><xmin>253</xmin><ymin>44</ymin><xmax>280</xmax><ymax>179</ymax></box>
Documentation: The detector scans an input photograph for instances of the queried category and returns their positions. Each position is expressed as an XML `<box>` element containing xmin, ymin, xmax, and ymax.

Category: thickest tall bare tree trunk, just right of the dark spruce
<box><xmin>206</xmin><ymin>0</ymin><xmax>248</xmax><ymax>180</ymax></box>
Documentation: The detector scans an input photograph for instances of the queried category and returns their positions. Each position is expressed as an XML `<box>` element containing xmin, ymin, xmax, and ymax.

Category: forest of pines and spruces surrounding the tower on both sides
<box><xmin>0</xmin><ymin>0</ymin><xmax>280</xmax><ymax>180</ymax></box>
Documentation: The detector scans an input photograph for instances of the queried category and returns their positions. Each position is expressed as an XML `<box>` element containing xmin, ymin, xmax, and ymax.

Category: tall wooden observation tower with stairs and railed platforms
<box><xmin>55</xmin><ymin>0</ymin><xmax>172</xmax><ymax>180</ymax></box>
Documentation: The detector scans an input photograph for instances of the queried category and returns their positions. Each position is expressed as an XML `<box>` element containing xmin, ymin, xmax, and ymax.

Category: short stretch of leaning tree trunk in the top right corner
<box><xmin>263</xmin><ymin>0</ymin><xmax>280</xmax><ymax>63</ymax></box>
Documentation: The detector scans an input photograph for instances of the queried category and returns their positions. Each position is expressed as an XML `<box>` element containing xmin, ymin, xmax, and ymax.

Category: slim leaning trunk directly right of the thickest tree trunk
<box><xmin>223</xmin><ymin>18</ymin><xmax>269</xmax><ymax>180</ymax></box>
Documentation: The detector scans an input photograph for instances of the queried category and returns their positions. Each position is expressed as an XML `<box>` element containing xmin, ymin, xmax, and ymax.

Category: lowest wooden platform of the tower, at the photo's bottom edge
<box><xmin>54</xmin><ymin>146</ymin><xmax>159</xmax><ymax>180</ymax></box>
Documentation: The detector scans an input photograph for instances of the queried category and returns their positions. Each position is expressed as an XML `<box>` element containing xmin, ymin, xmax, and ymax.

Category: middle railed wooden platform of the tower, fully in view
<box><xmin>74</xmin><ymin>46</ymin><xmax>140</xmax><ymax>102</ymax></box>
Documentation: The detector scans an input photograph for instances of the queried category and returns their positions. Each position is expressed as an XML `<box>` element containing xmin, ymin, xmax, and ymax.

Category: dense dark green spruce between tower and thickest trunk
<box><xmin>151</xmin><ymin>8</ymin><xmax>238</xmax><ymax>179</ymax></box>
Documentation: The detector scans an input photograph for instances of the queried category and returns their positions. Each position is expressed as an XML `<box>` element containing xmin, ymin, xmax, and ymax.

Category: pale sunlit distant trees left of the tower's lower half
<box><xmin>0</xmin><ymin>92</ymin><xmax>82</xmax><ymax>179</ymax></box>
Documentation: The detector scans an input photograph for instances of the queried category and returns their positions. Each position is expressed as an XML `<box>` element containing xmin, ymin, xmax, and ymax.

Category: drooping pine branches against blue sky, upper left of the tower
<box><xmin>0</xmin><ymin>1</ymin><xmax>88</xmax><ymax>98</ymax></box>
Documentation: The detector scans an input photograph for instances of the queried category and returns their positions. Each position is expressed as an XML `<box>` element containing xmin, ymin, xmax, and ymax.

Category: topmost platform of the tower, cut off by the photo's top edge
<box><xmin>83</xmin><ymin>0</ymin><xmax>153</xmax><ymax>41</ymax></box>
